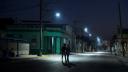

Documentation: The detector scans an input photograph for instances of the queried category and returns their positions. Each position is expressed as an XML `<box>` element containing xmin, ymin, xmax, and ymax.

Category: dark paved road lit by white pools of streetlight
<box><xmin>0</xmin><ymin>53</ymin><xmax>128</xmax><ymax>72</ymax></box>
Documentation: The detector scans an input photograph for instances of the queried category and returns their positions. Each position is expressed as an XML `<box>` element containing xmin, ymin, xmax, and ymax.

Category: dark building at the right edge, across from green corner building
<box><xmin>110</xmin><ymin>29</ymin><xmax>128</xmax><ymax>56</ymax></box>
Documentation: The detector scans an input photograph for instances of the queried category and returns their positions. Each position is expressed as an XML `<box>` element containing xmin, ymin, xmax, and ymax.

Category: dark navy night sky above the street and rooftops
<box><xmin>0</xmin><ymin>0</ymin><xmax>128</xmax><ymax>39</ymax></box>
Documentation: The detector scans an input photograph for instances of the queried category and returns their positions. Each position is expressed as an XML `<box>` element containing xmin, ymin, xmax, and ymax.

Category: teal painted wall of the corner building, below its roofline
<box><xmin>8</xmin><ymin>29</ymin><xmax>68</xmax><ymax>54</ymax></box>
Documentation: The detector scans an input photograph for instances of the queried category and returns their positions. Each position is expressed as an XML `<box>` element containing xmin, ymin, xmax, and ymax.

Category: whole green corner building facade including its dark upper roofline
<box><xmin>7</xmin><ymin>24</ymin><xmax>72</xmax><ymax>54</ymax></box>
